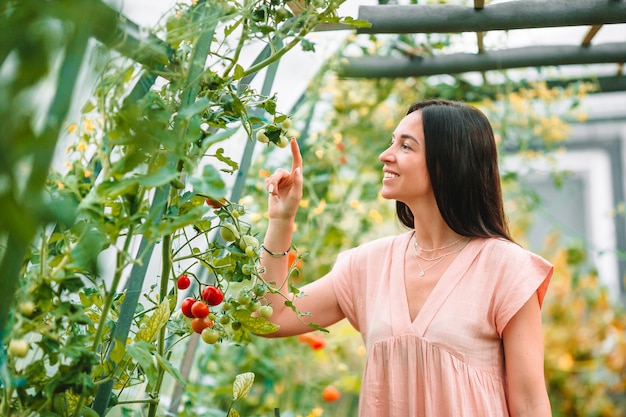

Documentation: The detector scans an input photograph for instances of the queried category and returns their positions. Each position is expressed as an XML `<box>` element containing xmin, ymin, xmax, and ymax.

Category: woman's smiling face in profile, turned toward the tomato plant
<box><xmin>379</xmin><ymin>111</ymin><xmax>434</xmax><ymax>206</ymax></box>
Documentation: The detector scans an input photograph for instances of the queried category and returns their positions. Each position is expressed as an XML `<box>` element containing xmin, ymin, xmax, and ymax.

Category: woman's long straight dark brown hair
<box><xmin>396</xmin><ymin>100</ymin><xmax>513</xmax><ymax>241</ymax></box>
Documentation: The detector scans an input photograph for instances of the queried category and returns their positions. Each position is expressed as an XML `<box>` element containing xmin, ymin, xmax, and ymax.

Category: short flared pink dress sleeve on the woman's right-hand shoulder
<box><xmin>494</xmin><ymin>244</ymin><xmax>554</xmax><ymax>336</ymax></box>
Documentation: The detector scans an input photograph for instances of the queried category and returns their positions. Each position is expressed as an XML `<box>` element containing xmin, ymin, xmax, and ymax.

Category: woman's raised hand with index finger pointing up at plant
<box><xmin>265</xmin><ymin>139</ymin><xmax>302</xmax><ymax>220</ymax></box>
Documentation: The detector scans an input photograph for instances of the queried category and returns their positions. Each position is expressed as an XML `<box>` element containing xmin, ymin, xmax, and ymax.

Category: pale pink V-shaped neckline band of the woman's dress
<box><xmin>395</xmin><ymin>233</ymin><xmax>486</xmax><ymax>336</ymax></box>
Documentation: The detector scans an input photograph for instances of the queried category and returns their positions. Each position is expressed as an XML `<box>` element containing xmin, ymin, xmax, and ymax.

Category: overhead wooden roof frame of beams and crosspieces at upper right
<box><xmin>320</xmin><ymin>0</ymin><xmax>626</xmax><ymax>92</ymax></box>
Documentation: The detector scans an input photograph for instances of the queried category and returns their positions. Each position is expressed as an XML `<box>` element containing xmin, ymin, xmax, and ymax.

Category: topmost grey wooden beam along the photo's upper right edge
<box><xmin>358</xmin><ymin>0</ymin><xmax>626</xmax><ymax>33</ymax></box>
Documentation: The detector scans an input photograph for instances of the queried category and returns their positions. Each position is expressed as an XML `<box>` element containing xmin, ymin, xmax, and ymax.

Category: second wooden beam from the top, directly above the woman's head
<box><xmin>338</xmin><ymin>43</ymin><xmax>626</xmax><ymax>78</ymax></box>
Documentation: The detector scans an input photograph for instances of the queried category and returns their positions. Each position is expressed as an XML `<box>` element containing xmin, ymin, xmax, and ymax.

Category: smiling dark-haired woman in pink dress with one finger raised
<box><xmin>261</xmin><ymin>100</ymin><xmax>553</xmax><ymax>417</ymax></box>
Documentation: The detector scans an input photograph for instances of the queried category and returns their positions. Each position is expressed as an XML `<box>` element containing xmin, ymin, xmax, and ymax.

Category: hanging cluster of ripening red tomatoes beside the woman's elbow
<box><xmin>178</xmin><ymin>275</ymin><xmax>224</xmax><ymax>344</ymax></box>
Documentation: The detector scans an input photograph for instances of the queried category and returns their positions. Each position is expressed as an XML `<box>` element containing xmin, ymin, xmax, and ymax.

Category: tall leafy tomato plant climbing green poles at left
<box><xmin>0</xmin><ymin>0</ymin><xmax>364</xmax><ymax>417</ymax></box>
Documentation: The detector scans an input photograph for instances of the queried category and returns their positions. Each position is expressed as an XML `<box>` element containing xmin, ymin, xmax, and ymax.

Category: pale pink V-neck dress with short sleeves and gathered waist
<box><xmin>328</xmin><ymin>232</ymin><xmax>553</xmax><ymax>417</ymax></box>
